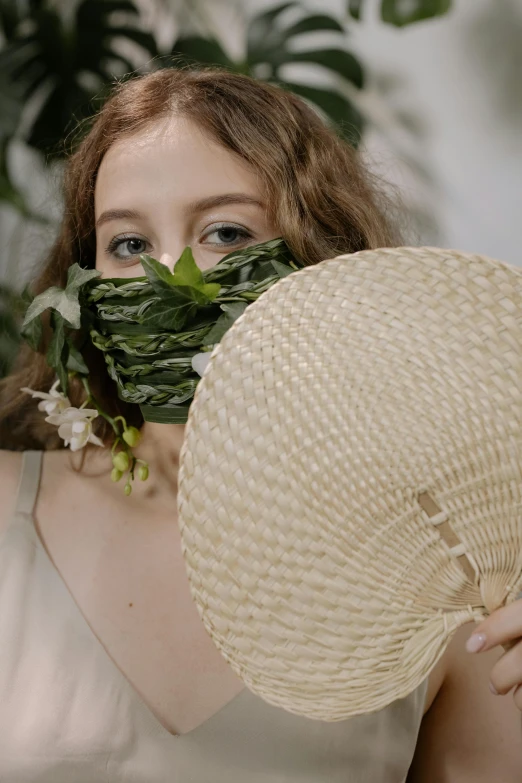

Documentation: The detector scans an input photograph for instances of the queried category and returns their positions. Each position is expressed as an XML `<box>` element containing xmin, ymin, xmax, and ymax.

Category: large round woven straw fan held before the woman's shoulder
<box><xmin>179</xmin><ymin>248</ymin><xmax>522</xmax><ymax>721</ymax></box>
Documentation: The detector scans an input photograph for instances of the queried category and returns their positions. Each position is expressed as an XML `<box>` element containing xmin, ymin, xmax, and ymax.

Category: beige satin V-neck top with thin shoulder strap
<box><xmin>0</xmin><ymin>451</ymin><xmax>426</xmax><ymax>783</ymax></box>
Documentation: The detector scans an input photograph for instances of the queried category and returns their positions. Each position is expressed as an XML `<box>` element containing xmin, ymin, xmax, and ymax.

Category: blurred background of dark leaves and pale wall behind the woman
<box><xmin>0</xmin><ymin>0</ymin><xmax>522</xmax><ymax>375</ymax></box>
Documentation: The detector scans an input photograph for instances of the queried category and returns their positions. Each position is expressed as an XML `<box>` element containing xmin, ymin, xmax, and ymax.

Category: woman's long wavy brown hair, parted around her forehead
<box><xmin>0</xmin><ymin>69</ymin><xmax>401</xmax><ymax>450</ymax></box>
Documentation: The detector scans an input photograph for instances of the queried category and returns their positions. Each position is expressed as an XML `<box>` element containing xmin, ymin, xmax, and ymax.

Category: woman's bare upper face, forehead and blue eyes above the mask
<box><xmin>95</xmin><ymin>117</ymin><xmax>279</xmax><ymax>277</ymax></box>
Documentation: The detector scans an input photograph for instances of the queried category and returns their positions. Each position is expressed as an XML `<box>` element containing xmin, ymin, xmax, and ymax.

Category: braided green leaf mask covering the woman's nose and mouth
<box><xmin>85</xmin><ymin>239</ymin><xmax>302</xmax><ymax>424</ymax></box>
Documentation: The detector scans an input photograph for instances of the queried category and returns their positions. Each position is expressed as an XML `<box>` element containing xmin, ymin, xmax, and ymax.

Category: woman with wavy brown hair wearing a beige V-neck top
<box><xmin>0</xmin><ymin>71</ymin><xmax>522</xmax><ymax>783</ymax></box>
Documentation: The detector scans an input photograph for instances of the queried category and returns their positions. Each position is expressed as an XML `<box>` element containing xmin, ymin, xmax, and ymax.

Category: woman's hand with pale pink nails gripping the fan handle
<box><xmin>466</xmin><ymin>600</ymin><xmax>522</xmax><ymax>711</ymax></box>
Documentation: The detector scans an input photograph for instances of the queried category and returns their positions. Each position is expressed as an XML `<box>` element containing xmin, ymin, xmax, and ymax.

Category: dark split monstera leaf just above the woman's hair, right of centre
<box><xmin>169</xmin><ymin>2</ymin><xmax>364</xmax><ymax>145</ymax></box>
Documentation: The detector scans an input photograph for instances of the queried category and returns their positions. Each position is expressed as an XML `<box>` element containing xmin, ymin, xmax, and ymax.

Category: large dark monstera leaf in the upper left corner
<box><xmin>0</xmin><ymin>0</ymin><xmax>157</xmax><ymax>154</ymax></box>
